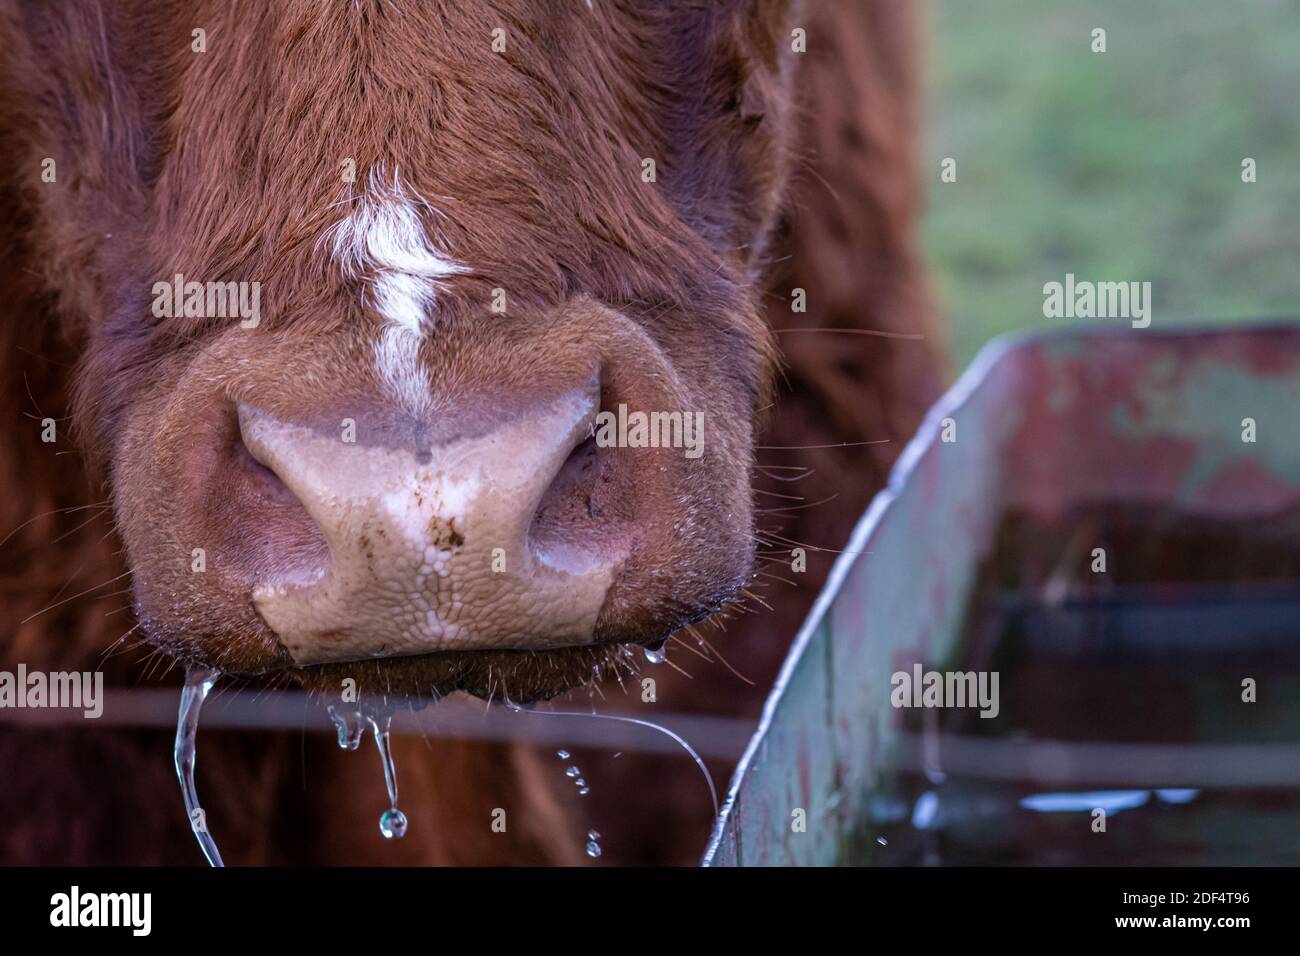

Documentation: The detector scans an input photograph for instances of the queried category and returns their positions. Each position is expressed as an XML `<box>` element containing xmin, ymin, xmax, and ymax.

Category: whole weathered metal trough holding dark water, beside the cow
<box><xmin>703</xmin><ymin>324</ymin><xmax>1300</xmax><ymax>866</ymax></box>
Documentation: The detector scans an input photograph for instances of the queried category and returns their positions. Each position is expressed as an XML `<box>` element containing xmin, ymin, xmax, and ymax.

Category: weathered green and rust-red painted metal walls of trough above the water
<box><xmin>703</xmin><ymin>324</ymin><xmax>1300</xmax><ymax>866</ymax></box>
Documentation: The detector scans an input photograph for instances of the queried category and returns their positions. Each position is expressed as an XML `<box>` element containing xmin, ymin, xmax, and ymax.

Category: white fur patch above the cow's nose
<box><xmin>326</xmin><ymin>173</ymin><xmax>469</xmax><ymax>414</ymax></box>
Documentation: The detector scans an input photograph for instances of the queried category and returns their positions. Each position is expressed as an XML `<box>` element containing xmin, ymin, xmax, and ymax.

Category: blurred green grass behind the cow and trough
<box><xmin>923</xmin><ymin>0</ymin><xmax>1300</xmax><ymax>368</ymax></box>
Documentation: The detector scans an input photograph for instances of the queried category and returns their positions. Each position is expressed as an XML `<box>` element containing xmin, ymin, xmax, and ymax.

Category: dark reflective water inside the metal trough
<box><xmin>848</xmin><ymin>502</ymin><xmax>1300</xmax><ymax>866</ymax></box>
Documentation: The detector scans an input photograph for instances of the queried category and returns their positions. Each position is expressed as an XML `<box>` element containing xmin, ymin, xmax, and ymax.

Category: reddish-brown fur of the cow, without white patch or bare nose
<box><xmin>0</xmin><ymin>0</ymin><xmax>939</xmax><ymax>864</ymax></box>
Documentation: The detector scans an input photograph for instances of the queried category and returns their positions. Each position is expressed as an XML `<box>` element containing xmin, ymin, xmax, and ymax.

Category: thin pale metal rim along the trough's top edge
<box><xmin>699</xmin><ymin>317</ymin><xmax>1296</xmax><ymax>866</ymax></box>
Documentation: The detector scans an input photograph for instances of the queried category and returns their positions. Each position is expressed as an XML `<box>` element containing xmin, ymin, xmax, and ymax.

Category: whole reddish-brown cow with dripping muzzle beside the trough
<box><xmin>0</xmin><ymin>0</ymin><xmax>940</xmax><ymax>864</ymax></box>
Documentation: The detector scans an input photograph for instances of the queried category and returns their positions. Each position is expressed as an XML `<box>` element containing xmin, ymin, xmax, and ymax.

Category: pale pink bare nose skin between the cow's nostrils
<box><xmin>239</xmin><ymin>389</ymin><xmax>621</xmax><ymax>665</ymax></box>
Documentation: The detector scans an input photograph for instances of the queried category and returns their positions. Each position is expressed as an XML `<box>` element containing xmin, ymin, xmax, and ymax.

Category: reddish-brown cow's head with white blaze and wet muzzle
<box><xmin>0</xmin><ymin>0</ymin><xmax>790</xmax><ymax>700</ymax></box>
